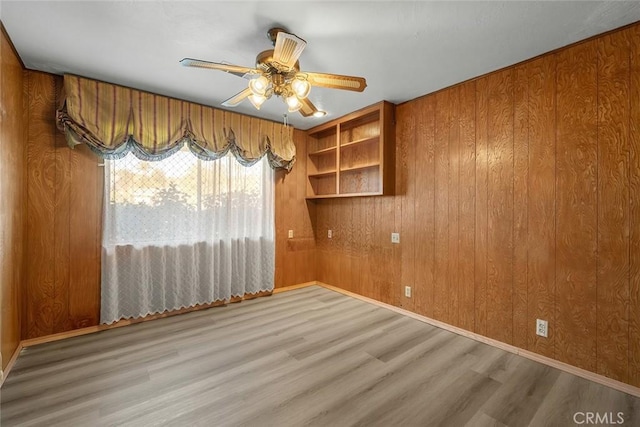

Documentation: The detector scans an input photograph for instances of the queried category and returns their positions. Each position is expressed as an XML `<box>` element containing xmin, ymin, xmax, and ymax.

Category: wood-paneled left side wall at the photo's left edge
<box><xmin>0</xmin><ymin>24</ymin><xmax>26</xmax><ymax>370</ymax></box>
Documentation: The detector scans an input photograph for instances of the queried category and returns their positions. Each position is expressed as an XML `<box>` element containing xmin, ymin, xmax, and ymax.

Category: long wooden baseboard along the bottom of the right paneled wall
<box><xmin>316</xmin><ymin>282</ymin><xmax>640</xmax><ymax>397</ymax></box>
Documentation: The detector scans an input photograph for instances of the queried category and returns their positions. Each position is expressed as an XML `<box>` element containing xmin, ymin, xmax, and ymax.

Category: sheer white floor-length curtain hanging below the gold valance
<box><xmin>100</xmin><ymin>148</ymin><xmax>275</xmax><ymax>323</ymax></box>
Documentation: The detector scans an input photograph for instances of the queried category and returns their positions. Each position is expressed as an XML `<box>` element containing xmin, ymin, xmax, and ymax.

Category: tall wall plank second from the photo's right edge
<box><xmin>596</xmin><ymin>31</ymin><xmax>629</xmax><ymax>381</ymax></box>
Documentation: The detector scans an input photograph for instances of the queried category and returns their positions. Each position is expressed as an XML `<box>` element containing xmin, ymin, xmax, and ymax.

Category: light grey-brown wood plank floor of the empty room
<box><xmin>0</xmin><ymin>286</ymin><xmax>640</xmax><ymax>427</ymax></box>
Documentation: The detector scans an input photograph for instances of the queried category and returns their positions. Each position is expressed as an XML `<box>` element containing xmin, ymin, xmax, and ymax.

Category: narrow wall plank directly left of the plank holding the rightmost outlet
<box><xmin>513</xmin><ymin>65</ymin><xmax>529</xmax><ymax>348</ymax></box>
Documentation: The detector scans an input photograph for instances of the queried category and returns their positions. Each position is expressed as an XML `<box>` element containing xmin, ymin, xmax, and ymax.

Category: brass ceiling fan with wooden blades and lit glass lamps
<box><xmin>180</xmin><ymin>28</ymin><xmax>367</xmax><ymax>117</ymax></box>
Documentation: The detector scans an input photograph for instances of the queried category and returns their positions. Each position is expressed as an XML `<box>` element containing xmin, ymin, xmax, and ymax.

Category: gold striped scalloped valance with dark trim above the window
<box><xmin>57</xmin><ymin>75</ymin><xmax>296</xmax><ymax>170</ymax></box>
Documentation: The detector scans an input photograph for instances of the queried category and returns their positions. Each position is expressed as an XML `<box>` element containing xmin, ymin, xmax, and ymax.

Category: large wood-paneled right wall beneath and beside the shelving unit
<box><xmin>316</xmin><ymin>25</ymin><xmax>640</xmax><ymax>386</ymax></box>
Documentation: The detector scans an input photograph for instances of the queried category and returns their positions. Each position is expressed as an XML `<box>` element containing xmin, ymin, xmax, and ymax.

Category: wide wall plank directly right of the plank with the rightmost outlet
<box><xmin>554</xmin><ymin>41</ymin><xmax>598</xmax><ymax>371</ymax></box>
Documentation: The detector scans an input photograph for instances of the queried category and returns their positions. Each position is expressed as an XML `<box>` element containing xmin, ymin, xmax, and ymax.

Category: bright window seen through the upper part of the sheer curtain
<box><xmin>104</xmin><ymin>147</ymin><xmax>273</xmax><ymax>246</ymax></box>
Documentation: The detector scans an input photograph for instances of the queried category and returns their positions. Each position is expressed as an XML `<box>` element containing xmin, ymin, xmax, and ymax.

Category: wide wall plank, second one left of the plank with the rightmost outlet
<box><xmin>487</xmin><ymin>70</ymin><xmax>513</xmax><ymax>344</ymax></box>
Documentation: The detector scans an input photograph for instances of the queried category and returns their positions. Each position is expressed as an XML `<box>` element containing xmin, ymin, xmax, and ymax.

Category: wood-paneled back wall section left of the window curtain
<box><xmin>22</xmin><ymin>71</ymin><xmax>102</xmax><ymax>339</ymax></box>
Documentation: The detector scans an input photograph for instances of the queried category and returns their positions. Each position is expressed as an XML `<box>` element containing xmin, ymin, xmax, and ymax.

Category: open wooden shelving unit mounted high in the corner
<box><xmin>307</xmin><ymin>101</ymin><xmax>395</xmax><ymax>199</ymax></box>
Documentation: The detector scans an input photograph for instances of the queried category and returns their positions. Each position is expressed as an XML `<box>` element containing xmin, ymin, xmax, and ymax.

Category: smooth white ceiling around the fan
<box><xmin>0</xmin><ymin>0</ymin><xmax>640</xmax><ymax>129</ymax></box>
